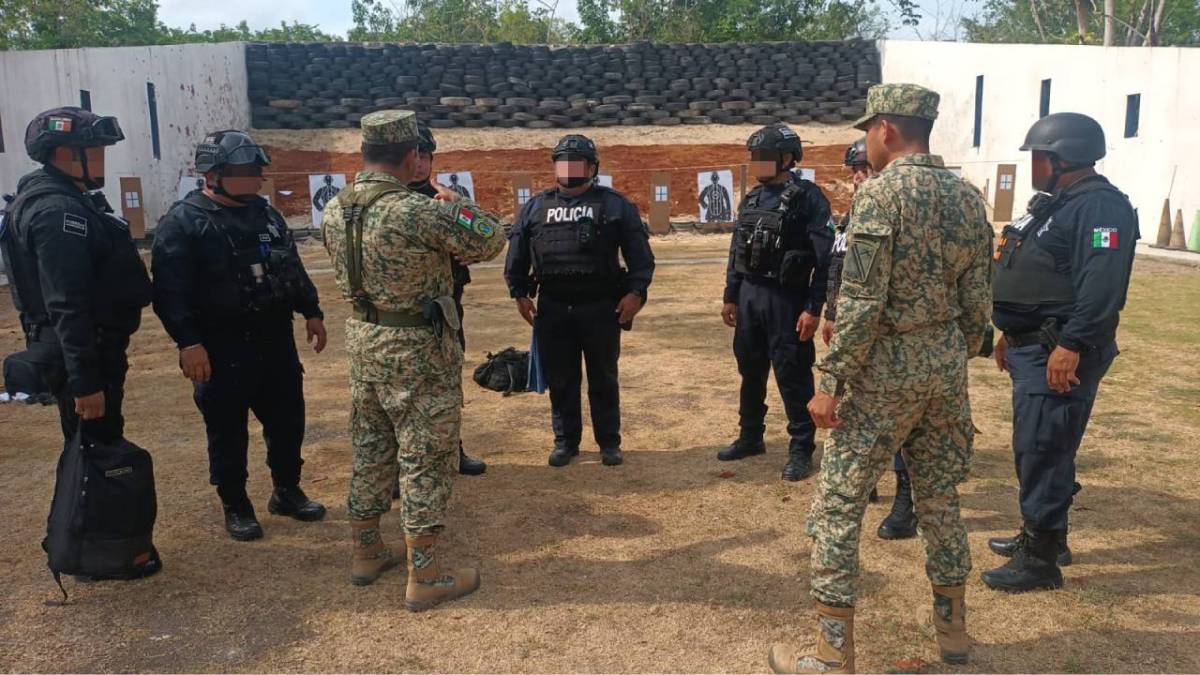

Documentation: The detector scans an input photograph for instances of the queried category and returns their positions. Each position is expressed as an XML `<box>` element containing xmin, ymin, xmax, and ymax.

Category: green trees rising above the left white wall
<box><xmin>0</xmin><ymin>0</ymin><xmax>337</xmax><ymax>49</ymax></box>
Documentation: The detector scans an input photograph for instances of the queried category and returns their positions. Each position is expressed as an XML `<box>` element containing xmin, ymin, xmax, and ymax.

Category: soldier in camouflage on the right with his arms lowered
<box><xmin>770</xmin><ymin>84</ymin><xmax>992</xmax><ymax>673</ymax></box>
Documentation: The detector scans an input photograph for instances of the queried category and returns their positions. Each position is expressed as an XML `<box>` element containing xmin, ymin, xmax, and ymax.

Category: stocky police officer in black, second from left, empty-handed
<box><xmin>151</xmin><ymin>130</ymin><xmax>325</xmax><ymax>540</ymax></box>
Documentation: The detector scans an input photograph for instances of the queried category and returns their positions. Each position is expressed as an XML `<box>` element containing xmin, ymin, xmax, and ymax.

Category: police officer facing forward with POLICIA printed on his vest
<box><xmin>504</xmin><ymin>135</ymin><xmax>654</xmax><ymax>466</ymax></box>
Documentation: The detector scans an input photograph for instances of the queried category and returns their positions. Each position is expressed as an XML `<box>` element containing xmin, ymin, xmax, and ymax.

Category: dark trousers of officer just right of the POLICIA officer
<box><xmin>733</xmin><ymin>280</ymin><xmax>817</xmax><ymax>454</ymax></box>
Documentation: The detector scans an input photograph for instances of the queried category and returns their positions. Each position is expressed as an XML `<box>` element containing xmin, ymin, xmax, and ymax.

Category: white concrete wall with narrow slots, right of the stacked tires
<box><xmin>880</xmin><ymin>41</ymin><xmax>1200</xmax><ymax>241</ymax></box>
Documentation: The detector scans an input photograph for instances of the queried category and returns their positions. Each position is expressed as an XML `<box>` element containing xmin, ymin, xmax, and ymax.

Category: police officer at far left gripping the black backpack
<box><xmin>0</xmin><ymin>107</ymin><xmax>162</xmax><ymax>579</ymax></box>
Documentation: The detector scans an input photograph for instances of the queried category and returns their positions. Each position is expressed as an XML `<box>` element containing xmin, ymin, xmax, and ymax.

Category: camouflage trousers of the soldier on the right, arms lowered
<box><xmin>808</xmin><ymin>374</ymin><xmax>974</xmax><ymax>607</ymax></box>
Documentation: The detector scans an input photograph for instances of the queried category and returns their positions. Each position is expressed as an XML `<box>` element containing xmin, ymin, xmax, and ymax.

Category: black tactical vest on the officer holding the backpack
<box><xmin>0</xmin><ymin>181</ymin><xmax>154</xmax><ymax>339</ymax></box>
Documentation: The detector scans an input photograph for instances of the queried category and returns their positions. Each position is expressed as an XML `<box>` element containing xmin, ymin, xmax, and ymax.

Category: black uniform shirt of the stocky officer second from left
<box><xmin>151</xmin><ymin>192</ymin><xmax>324</xmax><ymax>348</ymax></box>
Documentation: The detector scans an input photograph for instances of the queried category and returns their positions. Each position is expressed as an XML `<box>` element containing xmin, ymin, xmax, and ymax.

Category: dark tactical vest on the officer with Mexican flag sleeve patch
<box><xmin>991</xmin><ymin>179</ymin><xmax>1124</xmax><ymax>305</ymax></box>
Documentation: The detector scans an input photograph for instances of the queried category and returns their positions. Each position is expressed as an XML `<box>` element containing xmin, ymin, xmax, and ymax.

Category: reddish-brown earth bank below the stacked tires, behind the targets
<box><xmin>264</xmin><ymin>140</ymin><xmax>851</xmax><ymax>221</ymax></box>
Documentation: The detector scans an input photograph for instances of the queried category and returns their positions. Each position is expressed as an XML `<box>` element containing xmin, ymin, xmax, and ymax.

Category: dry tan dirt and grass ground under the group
<box><xmin>0</xmin><ymin>235</ymin><xmax>1200</xmax><ymax>673</ymax></box>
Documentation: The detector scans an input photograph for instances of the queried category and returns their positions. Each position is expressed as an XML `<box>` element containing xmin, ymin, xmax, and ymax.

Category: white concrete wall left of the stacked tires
<box><xmin>0</xmin><ymin>42</ymin><xmax>250</xmax><ymax>231</ymax></box>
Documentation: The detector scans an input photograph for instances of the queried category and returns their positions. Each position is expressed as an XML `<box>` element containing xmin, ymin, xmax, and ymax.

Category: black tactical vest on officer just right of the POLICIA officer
<box><xmin>733</xmin><ymin>181</ymin><xmax>816</xmax><ymax>291</ymax></box>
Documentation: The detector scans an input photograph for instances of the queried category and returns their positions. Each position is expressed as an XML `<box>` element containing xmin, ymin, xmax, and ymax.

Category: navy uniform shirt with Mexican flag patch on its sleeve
<box><xmin>992</xmin><ymin>177</ymin><xmax>1139</xmax><ymax>352</ymax></box>
